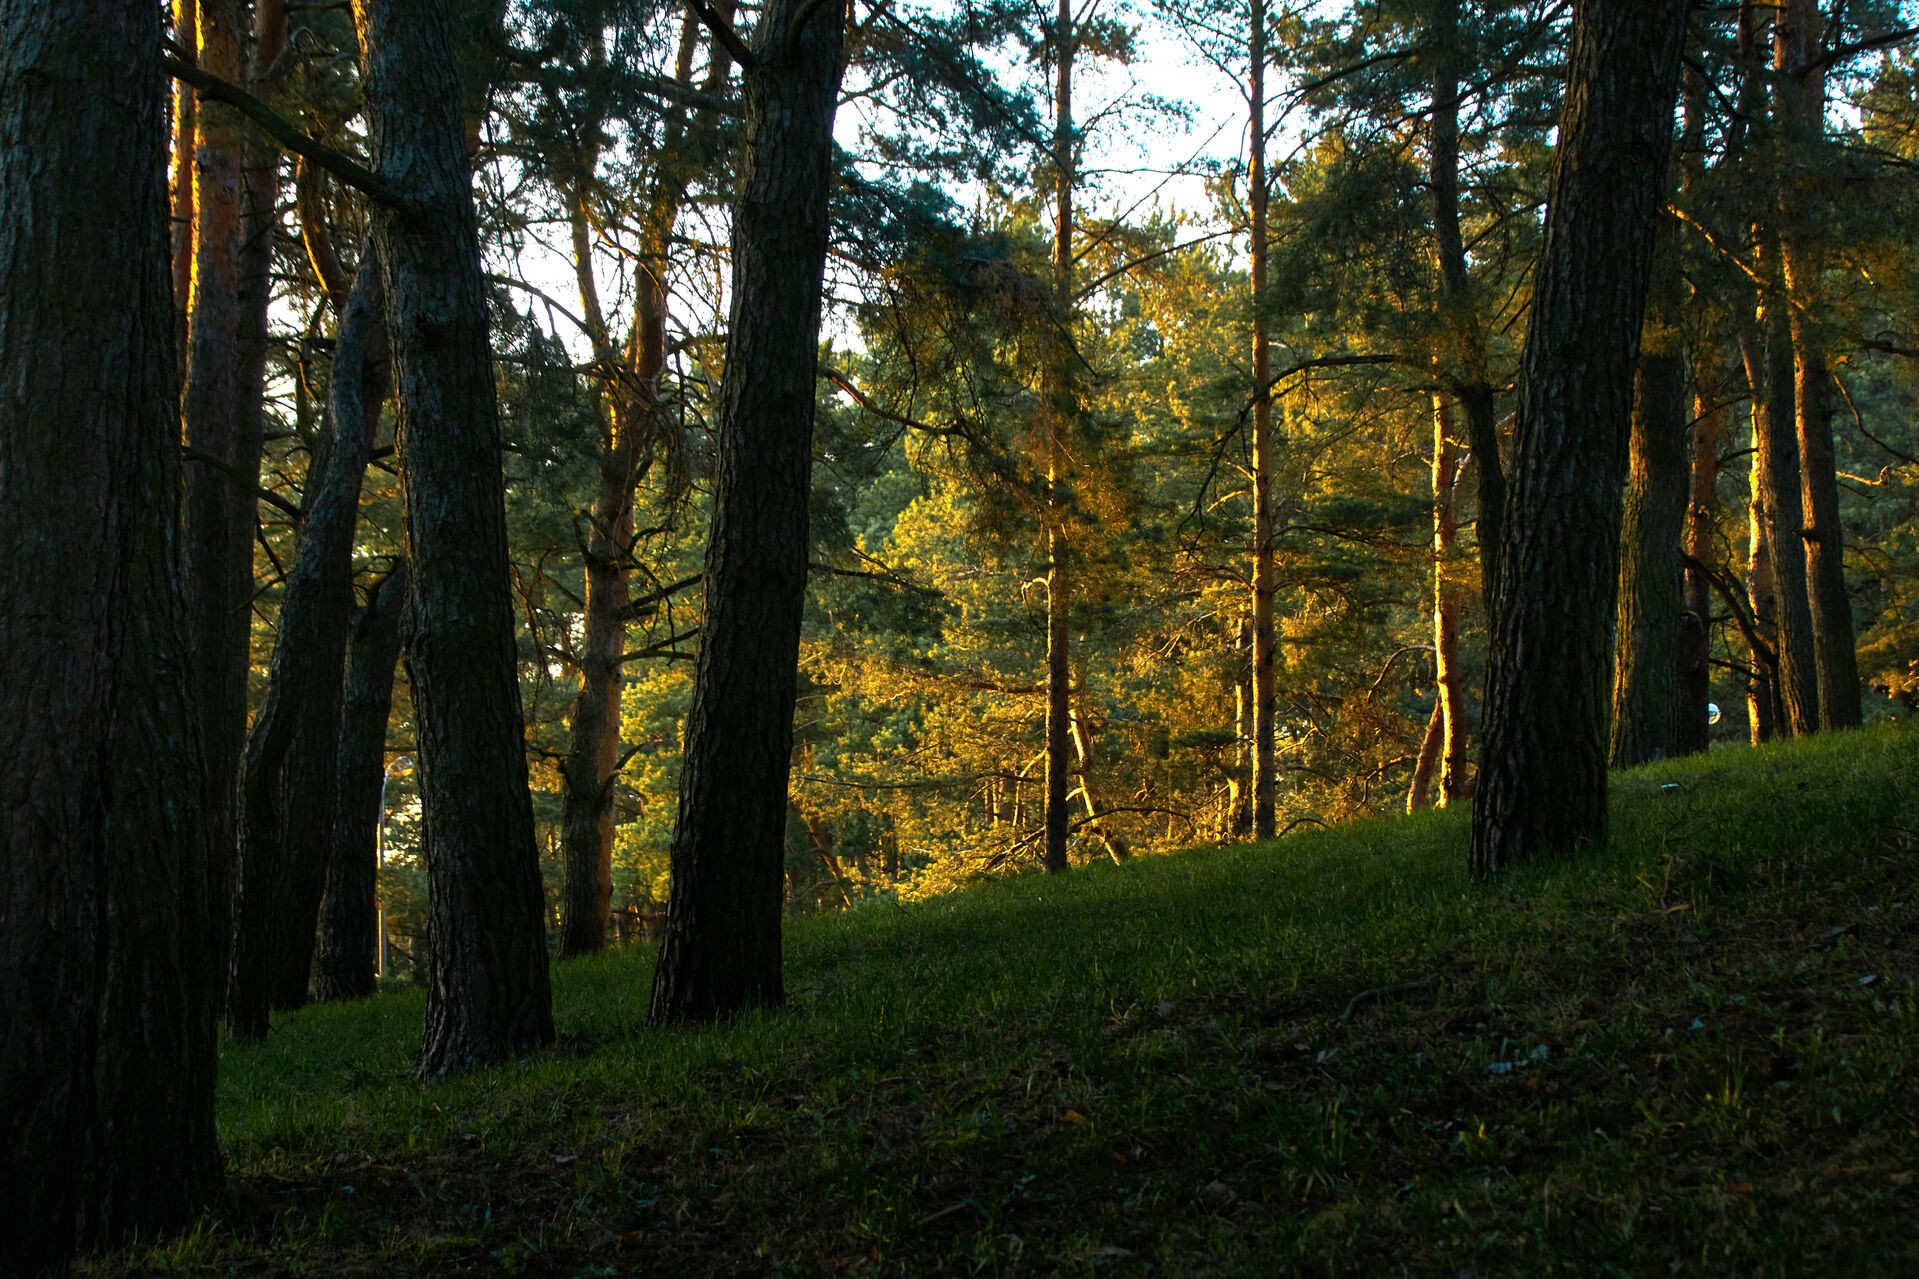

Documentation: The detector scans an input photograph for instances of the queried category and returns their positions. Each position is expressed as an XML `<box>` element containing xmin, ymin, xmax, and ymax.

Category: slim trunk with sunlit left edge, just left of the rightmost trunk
<box><xmin>1752</xmin><ymin>263</ymin><xmax>1819</xmax><ymax>737</ymax></box>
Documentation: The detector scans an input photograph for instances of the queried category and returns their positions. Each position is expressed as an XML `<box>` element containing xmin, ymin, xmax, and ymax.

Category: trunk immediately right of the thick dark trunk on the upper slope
<box><xmin>1612</xmin><ymin>253</ymin><xmax>1689</xmax><ymax>768</ymax></box>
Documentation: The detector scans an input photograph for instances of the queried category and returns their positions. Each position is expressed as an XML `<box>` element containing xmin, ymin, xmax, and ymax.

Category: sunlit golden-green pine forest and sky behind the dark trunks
<box><xmin>210</xmin><ymin>4</ymin><xmax>1919</xmax><ymax>937</ymax></box>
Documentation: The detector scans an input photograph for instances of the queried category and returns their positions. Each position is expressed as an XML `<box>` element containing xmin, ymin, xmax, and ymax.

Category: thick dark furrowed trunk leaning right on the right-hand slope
<box><xmin>1472</xmin><ymin>0</ymin><xmax>1689</xmax><ymax>876</ymax></box>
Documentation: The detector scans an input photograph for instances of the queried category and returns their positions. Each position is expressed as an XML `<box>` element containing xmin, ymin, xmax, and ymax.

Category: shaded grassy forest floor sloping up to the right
<box><xmin>81</xmin><ymin>726</ymin><xmax>1919</xmax><ymax>1279</ymax></box>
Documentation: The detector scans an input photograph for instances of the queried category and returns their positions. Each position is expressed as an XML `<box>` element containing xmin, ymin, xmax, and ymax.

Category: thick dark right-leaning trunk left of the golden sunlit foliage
<box><xmin>651</xmin><ymin>0</ymin><xmax>844</xmax><ymax>1024</ymax></box>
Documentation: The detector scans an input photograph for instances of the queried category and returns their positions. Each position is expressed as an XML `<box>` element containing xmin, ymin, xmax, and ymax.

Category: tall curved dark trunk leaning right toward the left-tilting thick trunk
<box><xmin>226</xmin><ymin>252</ymin><xmax>390</xmax><ymax>1039</ymax></box>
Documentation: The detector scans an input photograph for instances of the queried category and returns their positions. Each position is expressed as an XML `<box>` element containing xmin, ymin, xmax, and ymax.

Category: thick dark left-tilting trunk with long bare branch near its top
<box><xmin>355</xmin><ymin>0</ymin><xmax>553</xmax><ymax>1075</ymax></box>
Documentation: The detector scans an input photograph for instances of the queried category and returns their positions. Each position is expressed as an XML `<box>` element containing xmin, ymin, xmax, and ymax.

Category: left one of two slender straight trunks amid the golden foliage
<box><xmin>1040</xmin><ymin>0</ymin><xmax>1082</xmax><ymax>874</ymax></box>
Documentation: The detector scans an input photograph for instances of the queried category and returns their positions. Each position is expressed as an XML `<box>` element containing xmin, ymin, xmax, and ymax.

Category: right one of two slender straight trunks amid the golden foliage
<box><xmin>1243</xmin><ymin>0</ymin><xmax>1280</xmax><ymax>839</ymax></box>
